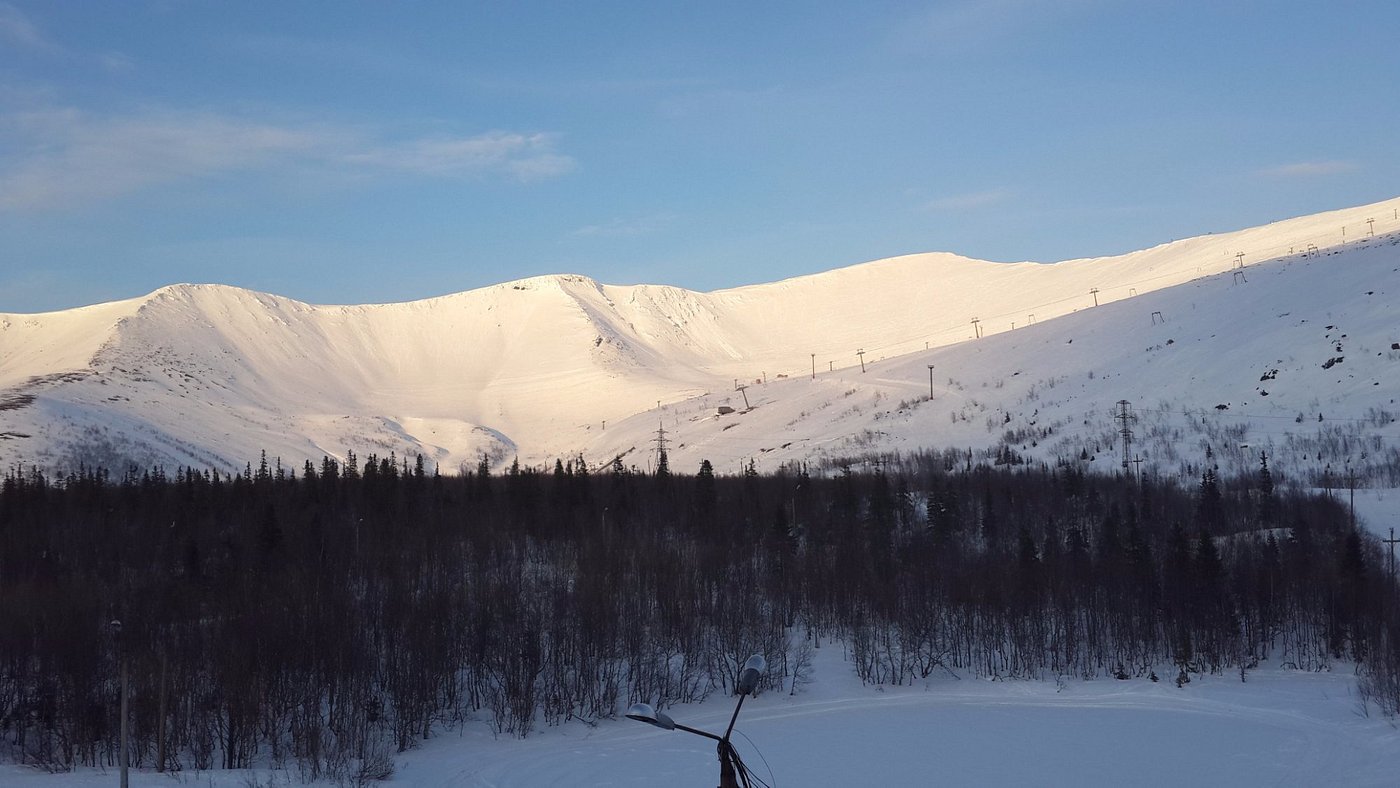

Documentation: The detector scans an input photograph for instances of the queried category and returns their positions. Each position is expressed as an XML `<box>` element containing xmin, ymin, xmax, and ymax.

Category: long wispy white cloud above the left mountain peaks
<box><xmin>0</xmin><ymin>109</ymin><xmax>574</xmax><ymax>211</ymax></box>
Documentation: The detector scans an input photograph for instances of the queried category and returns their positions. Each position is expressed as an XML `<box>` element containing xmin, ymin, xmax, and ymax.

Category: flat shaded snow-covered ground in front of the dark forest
<box><xmin>8</xmin><ymin>644</ymin><xmax>1400</xmax><ymax>788</ymax></box>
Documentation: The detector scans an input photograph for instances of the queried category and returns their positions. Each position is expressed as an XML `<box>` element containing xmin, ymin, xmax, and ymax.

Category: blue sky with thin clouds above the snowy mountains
<box><xmin>0</xmin><ymin>0</ymin><xmax>1400</xmax><ymax>312</ymax></box>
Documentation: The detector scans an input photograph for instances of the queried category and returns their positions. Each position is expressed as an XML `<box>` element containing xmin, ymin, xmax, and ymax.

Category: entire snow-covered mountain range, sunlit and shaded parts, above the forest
<box><xmin>0</xmin><ymin>199</ymin><xmax>1400</xmax><ymax>483</ymax></box>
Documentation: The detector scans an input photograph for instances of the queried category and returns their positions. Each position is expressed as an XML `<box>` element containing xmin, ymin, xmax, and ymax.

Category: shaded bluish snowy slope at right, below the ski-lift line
<box><xmin>599</xmin><ymin>214</ymin><xmax>1400</xmax><ymax>484</ymax></box>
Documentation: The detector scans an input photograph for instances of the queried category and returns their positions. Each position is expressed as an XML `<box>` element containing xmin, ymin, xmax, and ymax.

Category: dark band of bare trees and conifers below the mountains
<box><xmin>0</xmin><ymin>452</ymin><xmax>1400</xmax><ymax>781</ymax></box>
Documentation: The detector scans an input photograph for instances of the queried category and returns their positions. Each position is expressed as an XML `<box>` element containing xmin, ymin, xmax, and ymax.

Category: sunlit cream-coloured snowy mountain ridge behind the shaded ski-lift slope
<box><xmin>0</xmin><ymin>199</ymin><xmax>1400</xmax><ymax>478</ymax></box>
